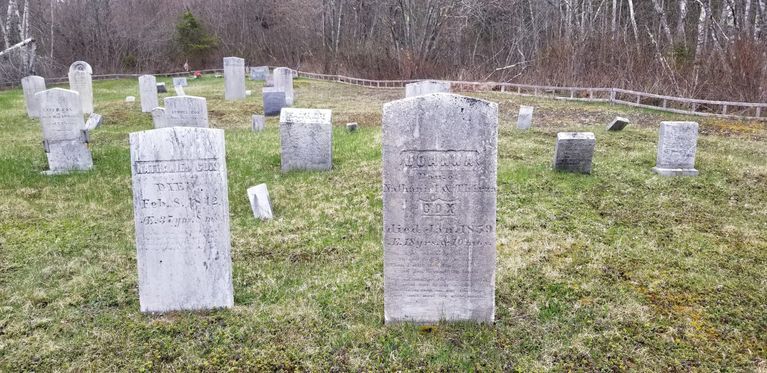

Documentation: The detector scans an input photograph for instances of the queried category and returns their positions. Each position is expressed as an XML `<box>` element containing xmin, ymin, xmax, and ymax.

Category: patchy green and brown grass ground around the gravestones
<box><xmin>0</xmin><ymin>78</ymin><xmax>767</xmax><ymax>372</ymax></box>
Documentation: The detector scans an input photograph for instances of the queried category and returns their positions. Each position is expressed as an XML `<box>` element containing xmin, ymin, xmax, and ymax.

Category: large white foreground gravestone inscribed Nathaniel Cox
<box><xmin>130</xmin><ymin>127</ymin><xmax>234</xmax><ymax>312</ymax></box>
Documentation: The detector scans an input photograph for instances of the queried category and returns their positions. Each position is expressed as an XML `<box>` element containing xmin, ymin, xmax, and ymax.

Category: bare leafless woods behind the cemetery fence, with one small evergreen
<box><xmin>0</xmin><ymin>0</ymin><xmax>767</xmax><ymax>101</ymax></box>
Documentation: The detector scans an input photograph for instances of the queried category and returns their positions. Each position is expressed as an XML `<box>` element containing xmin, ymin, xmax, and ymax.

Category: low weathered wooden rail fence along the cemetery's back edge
<box><xmin>0</xmin><ymin>66</ymin><xmax>767</xmax><ymax>121</ymax></box>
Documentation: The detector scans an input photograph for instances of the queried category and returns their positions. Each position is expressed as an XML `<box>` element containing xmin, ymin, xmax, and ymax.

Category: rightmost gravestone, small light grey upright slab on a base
<box><xmin>652</xmin><ymin>122</ymin><xmax>698</xmax><ymax>176</ymax></box>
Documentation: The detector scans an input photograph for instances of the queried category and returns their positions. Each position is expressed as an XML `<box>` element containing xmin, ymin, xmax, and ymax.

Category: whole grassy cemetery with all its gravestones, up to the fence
<box><xmin>0</xmin><ymin>67</ymin><xmax>767</xmax><ymax>371</ymax></box>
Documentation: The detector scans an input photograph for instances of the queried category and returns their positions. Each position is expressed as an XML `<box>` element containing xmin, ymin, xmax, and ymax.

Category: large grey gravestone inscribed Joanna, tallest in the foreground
<box><xmin>383</xmin><ymin>94</ymin><xmax>498</xmax><ymax>323</ymax></box>
